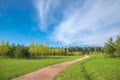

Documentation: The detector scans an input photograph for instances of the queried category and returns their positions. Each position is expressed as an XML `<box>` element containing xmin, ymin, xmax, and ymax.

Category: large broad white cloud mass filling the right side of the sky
<box><xmin>52</xmin><ymin>0</ymin><xmax>120</xmax><ymax>45</ymax></box>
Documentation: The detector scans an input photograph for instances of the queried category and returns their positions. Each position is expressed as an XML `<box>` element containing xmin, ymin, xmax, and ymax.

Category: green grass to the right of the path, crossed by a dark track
<box><xmin>54</xmin><ymin>54</ymin><xmax>120</xmax><ymax>80</ymax></box>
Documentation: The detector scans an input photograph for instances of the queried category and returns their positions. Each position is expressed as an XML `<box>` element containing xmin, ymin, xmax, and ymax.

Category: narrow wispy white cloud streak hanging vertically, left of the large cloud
<box><xmin>35</xmin><ymin>0</ymin><xmax>60</xmax><ymax>31</ymax></box>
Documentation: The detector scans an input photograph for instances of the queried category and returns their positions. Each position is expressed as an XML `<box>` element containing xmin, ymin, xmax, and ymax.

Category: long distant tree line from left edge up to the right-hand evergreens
<box><xmin>0</xmin><ymin>40</ymin><xmax>103</xmax><ymax>58</ymax></box>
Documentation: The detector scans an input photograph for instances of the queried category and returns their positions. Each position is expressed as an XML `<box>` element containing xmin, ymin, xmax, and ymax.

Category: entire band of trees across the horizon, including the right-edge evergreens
<box><xmin>0</xmin><ymin>36</ymin><xmax>120</xmax><ymax>58</ymax></box>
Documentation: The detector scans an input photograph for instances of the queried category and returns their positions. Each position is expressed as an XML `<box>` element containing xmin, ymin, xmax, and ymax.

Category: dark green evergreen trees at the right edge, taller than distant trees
<box><xmin>104</xmin><ymin>36</ymin><xmax>120</xmax><ymax>57</ymax></box>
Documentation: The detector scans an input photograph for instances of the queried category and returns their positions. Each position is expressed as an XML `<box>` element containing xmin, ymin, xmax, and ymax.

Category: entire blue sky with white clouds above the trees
<box><xmin>0</xmin><ymin>0</ymin><xmax>120</xmax><ymax>47</ymax></box>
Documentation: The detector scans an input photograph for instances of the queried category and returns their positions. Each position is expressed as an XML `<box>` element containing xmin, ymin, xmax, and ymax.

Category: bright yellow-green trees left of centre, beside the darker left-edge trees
<box><xmin>29</xmin><ymin>41</ymin><xmax>67</xmax><ymax>58</ymax></box>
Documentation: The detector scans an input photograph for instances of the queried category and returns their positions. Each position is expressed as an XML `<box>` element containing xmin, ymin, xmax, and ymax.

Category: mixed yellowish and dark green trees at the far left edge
<box><xmin>0</xmin><ymin>40</ymin><xmax>29</xmax><ymax>58</ymax></box>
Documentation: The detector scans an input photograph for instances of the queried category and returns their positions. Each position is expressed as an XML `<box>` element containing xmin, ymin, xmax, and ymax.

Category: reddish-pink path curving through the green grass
<box><xmin>12</xmin><ymin>56</ymin><xmax>89</xmax><ymax>80</ymax></box>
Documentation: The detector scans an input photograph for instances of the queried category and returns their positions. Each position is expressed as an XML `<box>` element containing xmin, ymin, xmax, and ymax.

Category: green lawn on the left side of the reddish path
<box><xmin>0</xmin><ymin>56</ymin><xmax>81</xmax><ymax>80</ymax></box>
